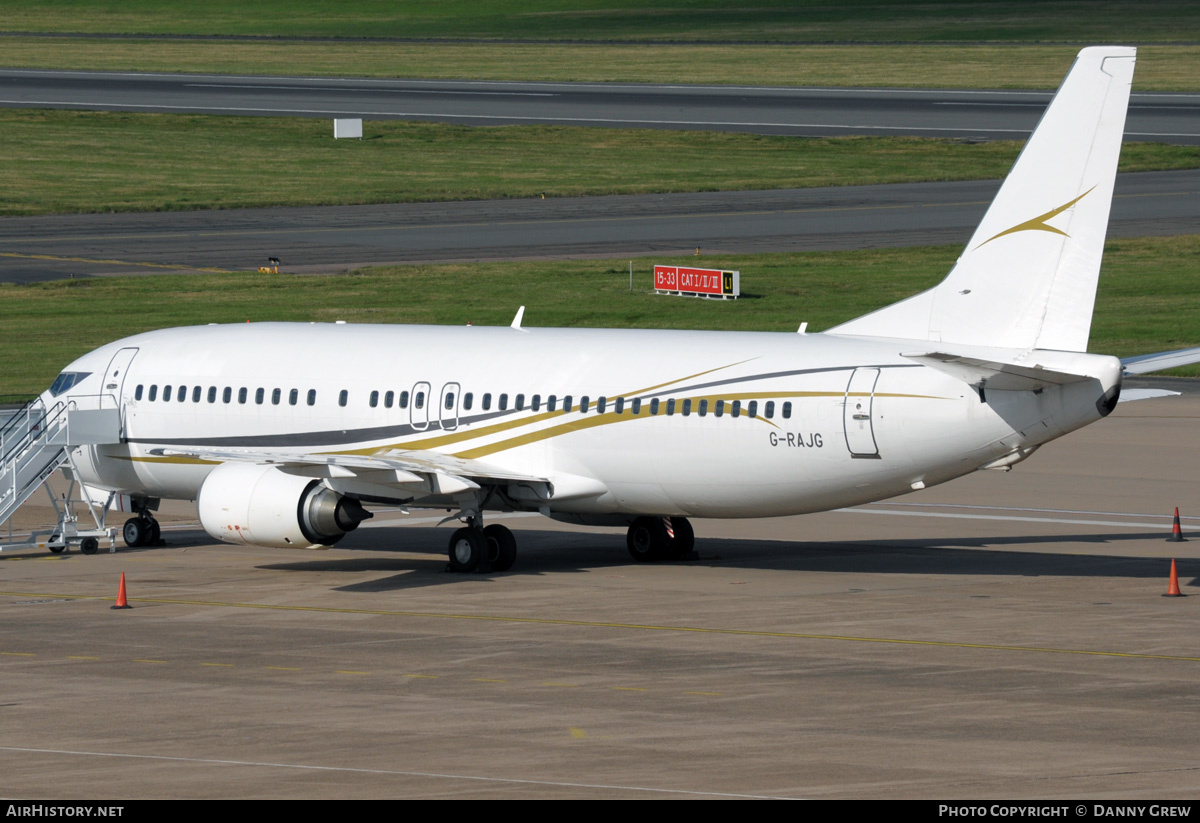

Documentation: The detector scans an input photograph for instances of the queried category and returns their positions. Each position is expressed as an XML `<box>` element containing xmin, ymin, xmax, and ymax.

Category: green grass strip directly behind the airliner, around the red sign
<box><xmin>0</xmin><ymin>235</ymin><xmax>1200</xmax><ymax>398</ymax></box>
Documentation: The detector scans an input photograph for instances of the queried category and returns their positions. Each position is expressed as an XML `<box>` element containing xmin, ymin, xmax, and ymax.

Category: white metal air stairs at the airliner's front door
<box><xmin>0</xmin><ymin>397</ymin><xmax>122</xmax><ymax>554</ymax></box>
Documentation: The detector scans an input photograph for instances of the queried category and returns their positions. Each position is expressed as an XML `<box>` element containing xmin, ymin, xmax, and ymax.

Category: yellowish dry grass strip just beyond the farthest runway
<box><xmin>7</xmin><ymin>39</ymin><xmax>1200</xmax><ymax>91</ymax></box>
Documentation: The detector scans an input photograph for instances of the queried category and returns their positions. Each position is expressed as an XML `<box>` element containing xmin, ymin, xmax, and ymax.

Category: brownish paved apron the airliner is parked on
<box><xmin>0</xmin><ymin>396</ymin><xmax>1200</xmax><ymax>800</ymax></box>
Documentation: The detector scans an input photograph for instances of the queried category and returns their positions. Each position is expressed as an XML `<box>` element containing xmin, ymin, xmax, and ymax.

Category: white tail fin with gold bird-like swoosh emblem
<box><xmin>828</xmin><ymin>47</ymin><xmax>1136</xmax><ymax>352</ymax></box>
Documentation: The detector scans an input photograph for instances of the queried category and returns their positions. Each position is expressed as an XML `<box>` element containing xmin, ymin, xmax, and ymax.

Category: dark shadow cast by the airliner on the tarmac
<box><xmin>226</xmin><ymin>529</ymin><xmax>1200</xmax><ymax>591</ymax></box>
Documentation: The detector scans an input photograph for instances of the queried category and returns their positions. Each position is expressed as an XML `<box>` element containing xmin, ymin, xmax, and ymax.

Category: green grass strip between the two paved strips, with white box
<box><xmin>0</xmin><ymin>109</ymin><xmax>1200</xmax><ymax>216</ymax></box>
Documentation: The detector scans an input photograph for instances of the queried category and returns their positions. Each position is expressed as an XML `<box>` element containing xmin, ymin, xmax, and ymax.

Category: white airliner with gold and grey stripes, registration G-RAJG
<box><xmin>2</xmin><ymin>47</ymin><xmax>1200</xmax><ymax>571</ymax></box>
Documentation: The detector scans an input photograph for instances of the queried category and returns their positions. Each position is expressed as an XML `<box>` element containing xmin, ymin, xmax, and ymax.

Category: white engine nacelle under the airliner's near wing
<box><xmin>196</xmin><ymin>463</ymin><xmax>371</xmax><ymax>548</ymax></box>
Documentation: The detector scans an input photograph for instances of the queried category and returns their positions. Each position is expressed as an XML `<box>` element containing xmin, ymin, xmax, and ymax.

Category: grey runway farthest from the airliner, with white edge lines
<box><xmin>0</xmin><ymin>69</ymin><xmax>1200</xmax><ymax>145</ymax></box>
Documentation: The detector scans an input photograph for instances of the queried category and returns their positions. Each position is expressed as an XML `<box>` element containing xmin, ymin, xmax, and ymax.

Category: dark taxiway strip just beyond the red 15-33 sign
<box><xmin>0</xmin><ymin>170</ymin><xmax>1200</xmax><ymax>283</ymax></box>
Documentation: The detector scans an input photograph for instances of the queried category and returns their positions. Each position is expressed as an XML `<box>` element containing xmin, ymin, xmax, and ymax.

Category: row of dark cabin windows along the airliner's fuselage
<box><xmin>133</xmin><ymin>384</ymin><xmax>792</xmax><ymax>419</ymax></box>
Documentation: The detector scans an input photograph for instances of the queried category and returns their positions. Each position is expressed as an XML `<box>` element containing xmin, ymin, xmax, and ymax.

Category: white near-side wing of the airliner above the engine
<box><xmin>150</xmin><ymin>447</ymin><xmax>607</xmax><ymax>503</ymax></box>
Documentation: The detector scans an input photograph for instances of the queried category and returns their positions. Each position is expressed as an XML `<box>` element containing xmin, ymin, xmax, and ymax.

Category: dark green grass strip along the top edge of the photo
<box><xmin>0</xmin><ymin>0</ymin><xmax>1200</xmax><ymax>43</ymax></box>
